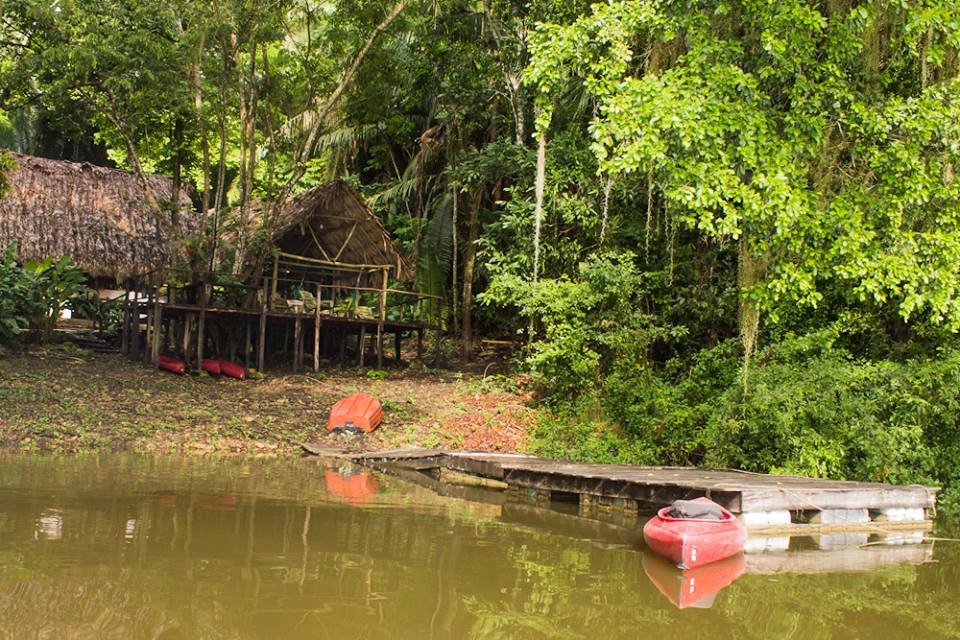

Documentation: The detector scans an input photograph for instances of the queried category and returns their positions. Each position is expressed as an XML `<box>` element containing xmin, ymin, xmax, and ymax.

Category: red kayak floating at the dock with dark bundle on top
<box><xmin>643</xmin><ymin>498</ymin><xmax>747</xmax><ymax>569</ymax></box>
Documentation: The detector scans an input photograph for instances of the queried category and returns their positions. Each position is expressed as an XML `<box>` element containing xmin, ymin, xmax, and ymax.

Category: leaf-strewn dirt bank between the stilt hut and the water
<box><xmin>0</xmin><ymin>348</ymin><xmax>535</xmax><ymax>454</ymax></box>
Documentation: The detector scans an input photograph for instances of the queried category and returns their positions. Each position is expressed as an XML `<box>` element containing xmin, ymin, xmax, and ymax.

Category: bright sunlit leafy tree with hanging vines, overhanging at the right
<box><xmin>530</xmin><ymin>1</ymin><xmax>960</xmax><ymax>378</ymax></box>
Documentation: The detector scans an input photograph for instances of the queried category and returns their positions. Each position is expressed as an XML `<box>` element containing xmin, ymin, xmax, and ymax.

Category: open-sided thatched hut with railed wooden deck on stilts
<box><xmin>122</xmin><ymin>181</ymin><xmax>440</xmax><ymax>371</ymax></box>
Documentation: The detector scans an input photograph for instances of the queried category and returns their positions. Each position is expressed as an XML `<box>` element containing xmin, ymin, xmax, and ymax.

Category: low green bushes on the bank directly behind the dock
<box><xmin>533</xmin><ymin>334</ymin><xmax>960</xmax><ymax>511</ymax></box>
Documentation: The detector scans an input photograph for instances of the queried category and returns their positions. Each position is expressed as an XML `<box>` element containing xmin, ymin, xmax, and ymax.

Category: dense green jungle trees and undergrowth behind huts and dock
<box><xmin>0</xmin><ymin>0</ymin><xmax>960</xmax><ymax>504</ymax></box>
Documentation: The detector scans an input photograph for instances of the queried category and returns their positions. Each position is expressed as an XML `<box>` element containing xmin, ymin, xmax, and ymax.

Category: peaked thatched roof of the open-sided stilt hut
<box><xmin>240</xmin><ymin>180</ymin><xmax>413</xmax><ymax>281</ymax></box>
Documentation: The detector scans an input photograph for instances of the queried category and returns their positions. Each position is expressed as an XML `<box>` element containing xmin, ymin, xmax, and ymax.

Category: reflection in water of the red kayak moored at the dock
<box><xmin>643</xmin><ymin>553</ymin><xmax>746</xmax><ymax>609</ymax></box>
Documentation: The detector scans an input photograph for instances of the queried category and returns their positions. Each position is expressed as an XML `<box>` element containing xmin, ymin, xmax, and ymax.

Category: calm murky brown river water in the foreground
<box><xmin>0</xmin><ymin>455</ymin><xmax>960</xmax><ymax>640</ymax></box>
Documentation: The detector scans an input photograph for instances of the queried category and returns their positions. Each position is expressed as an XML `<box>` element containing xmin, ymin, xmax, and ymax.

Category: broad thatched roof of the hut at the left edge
<box><xmin>0</xmin><ymin>153</ymin><xmax>198</xmax><ymax>281</ymax></box>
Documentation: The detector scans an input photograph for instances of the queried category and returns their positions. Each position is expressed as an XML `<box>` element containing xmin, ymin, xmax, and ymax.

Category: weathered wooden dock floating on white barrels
<box><xmin>346</xmin><ymin>449</ymin><xmax>937</xmax><ymax>535</ymax></box>
